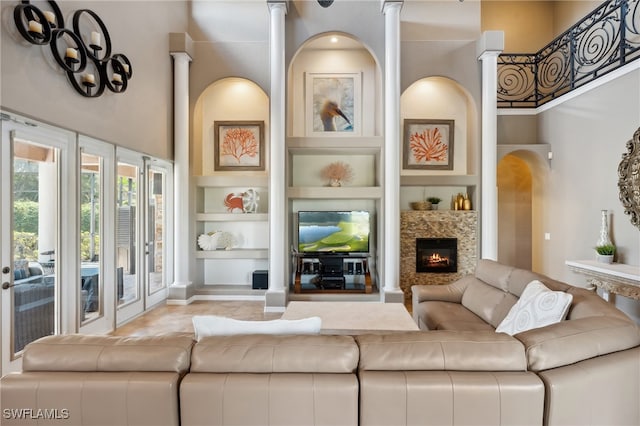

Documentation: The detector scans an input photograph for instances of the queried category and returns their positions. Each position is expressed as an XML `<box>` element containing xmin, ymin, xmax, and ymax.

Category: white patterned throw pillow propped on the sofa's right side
<box><xmin>496</xmin><ymin>280</ymin><xmax>573</xmax><ymax>336</ymax></box>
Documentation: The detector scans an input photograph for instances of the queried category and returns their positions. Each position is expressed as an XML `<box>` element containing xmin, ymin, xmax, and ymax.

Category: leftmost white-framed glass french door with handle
<box><xmin>0</xmin><ymin>114</ymin><xmax>75</xmax><ymax>374</ymax></box>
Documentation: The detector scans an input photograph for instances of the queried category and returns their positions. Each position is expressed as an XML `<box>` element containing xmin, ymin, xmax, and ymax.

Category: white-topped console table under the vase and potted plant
<box><xmin>565</xmin><ymin>260</ymin><xmax>640</xmax><ymax>301</ymax></box>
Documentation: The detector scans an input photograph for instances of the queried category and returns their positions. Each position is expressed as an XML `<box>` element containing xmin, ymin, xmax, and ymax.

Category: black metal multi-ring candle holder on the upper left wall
<box><xmin>13</xmin><ymin>0</ymin><xmax>133</xmax><ymax>98</ymax></box>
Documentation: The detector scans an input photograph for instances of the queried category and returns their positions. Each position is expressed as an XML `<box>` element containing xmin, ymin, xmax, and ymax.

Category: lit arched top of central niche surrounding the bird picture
<box><xmin>287</xmin><ymin>31</ymin><xmax>383</xmax><ymax>137</ymax></box>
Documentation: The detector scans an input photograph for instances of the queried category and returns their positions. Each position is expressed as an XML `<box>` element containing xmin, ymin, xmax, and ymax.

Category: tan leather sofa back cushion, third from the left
<box><xmin>356</xmin><ymin>330</ymin><xmax>527</xmax><ymax>371</ymax></box>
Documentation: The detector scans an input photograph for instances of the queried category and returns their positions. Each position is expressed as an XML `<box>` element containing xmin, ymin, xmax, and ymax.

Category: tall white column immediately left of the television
<box><xmin>265</xmin><ymin>1</ymin><xmax>288</xmax><ymax>311</ymax></box>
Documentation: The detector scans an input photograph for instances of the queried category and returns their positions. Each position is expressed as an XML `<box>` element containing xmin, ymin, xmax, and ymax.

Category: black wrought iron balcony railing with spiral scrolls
<box><xmin>498</xmin><ymin>0</ymin><xmax>640</xmax><ymax>108</ymax></box>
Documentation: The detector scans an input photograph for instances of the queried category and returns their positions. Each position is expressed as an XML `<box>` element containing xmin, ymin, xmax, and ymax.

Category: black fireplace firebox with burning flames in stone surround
<box><xmin>416</xmin><ymin>238</ymin><xmax>458</xmax><ymax>272</ymax></box>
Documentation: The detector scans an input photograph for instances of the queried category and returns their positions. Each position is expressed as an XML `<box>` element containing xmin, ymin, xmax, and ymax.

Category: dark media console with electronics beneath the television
<box><xmin>293</xmin><ymin>253</ymin><xmax>373</xmax><ymax>294</ymax></box>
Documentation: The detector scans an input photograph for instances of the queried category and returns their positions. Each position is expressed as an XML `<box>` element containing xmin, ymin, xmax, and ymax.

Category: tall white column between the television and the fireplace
<box><xmin>382</xmin><ymin>0</ymin><xmax>404</xmax><ymax>302</ymax></box>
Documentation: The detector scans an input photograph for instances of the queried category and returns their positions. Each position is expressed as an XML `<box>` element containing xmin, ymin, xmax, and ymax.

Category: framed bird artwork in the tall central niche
<box><xmin>305</xmin><ymin>73</ymin><xmax>362</xmax><ymax>136</ymax></box>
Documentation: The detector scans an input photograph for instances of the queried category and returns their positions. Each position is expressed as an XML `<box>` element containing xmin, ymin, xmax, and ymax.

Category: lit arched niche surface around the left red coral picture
<box><xmin>192</xmin><ymin>77</ymin><xmax>270</xmax><ymax>175</ymax></box>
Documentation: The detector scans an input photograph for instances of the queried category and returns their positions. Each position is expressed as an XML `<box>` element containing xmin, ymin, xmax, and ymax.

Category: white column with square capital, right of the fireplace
<box><xmin>478</xmin><ymin>31</ymin><xmax>504</xmax><ymax>260</ymax></box>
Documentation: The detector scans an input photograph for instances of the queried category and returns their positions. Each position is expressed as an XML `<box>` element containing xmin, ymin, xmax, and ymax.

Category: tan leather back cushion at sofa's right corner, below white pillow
<box><xmin>514</xmin><ymin>316</ymin><xmax>640</xmax><ymax>371</ymax></box>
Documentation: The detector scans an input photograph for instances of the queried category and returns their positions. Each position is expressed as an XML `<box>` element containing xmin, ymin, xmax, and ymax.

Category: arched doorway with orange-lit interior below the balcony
<box><xmin>497</xmin><ymin>148</ymin><xmax>550</xmax><ymax>270</ymax></box>
